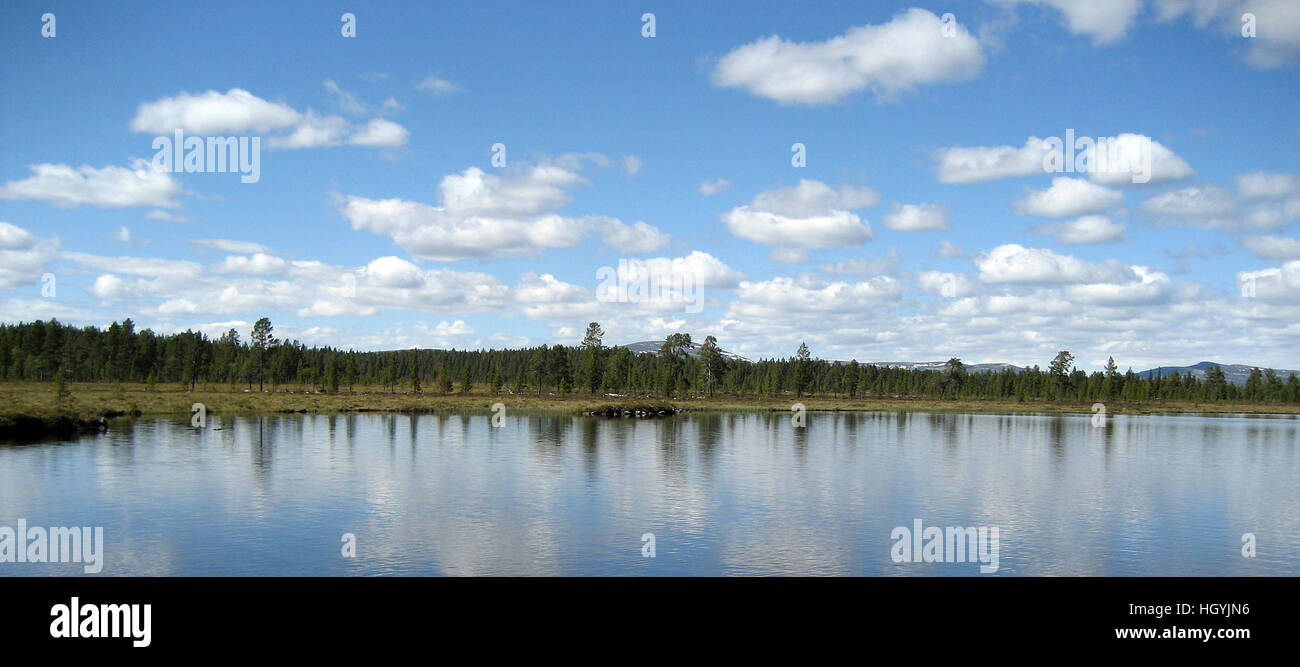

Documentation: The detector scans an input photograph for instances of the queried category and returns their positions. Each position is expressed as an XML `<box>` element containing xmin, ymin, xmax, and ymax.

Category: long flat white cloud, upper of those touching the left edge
<box><xmin>0</xmin><ymin>160</ymin><xmax>181</xmax><ymax>208</ymax></box>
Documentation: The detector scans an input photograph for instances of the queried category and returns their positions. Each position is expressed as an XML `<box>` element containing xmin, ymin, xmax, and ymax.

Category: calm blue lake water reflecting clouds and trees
<box><xmin>0</xmin><ymin>413</ymin><xmax>1300</xmax><ymax>576</ymax></box>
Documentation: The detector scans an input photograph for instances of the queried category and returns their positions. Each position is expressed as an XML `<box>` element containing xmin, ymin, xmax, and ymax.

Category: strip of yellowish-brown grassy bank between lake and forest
<box><xmin>0</xmin><ymin>382</ymin><xmax>1300</xmax><ymax>436</ymax></box>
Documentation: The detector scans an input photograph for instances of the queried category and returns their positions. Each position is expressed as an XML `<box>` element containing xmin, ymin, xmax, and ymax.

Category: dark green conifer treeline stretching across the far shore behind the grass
<box><xmin>0</xmin><ymin>317</ymin><xmax>1300</xmax><ymax>402</ymax></box>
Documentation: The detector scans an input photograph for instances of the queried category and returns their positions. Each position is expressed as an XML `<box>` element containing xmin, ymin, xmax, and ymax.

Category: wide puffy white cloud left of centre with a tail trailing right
<box><xmin>341</xmin><ymin>163</ymin><xmax>667</xmax><ymax>261</ymax></box>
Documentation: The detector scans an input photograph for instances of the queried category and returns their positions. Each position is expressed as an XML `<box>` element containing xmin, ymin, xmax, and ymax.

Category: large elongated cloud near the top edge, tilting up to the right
<box><xmin>711</xmin><ymin>9</ymin><xmax>985</xmax><ymax>105</ymax></box>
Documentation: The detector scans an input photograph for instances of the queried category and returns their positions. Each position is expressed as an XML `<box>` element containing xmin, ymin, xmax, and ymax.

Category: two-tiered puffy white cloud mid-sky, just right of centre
<box><xmin>722</xmin><ymin>179</ymin><xmax>880</xmax><ymax>250</ymax></box>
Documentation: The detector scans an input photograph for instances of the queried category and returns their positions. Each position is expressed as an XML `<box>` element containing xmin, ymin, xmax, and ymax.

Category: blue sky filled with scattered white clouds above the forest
<box><xmin>0</xmin><ymin>0</ymin><xmax>1300</xmax><ymax>369</ymax></box>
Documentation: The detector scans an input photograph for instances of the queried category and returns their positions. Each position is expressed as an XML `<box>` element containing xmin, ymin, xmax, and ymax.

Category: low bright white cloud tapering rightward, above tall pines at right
<box><xmin>972</xmin><ymin>243</ymin><xmax>1135</xmax><ymax>285</ymax></box>
